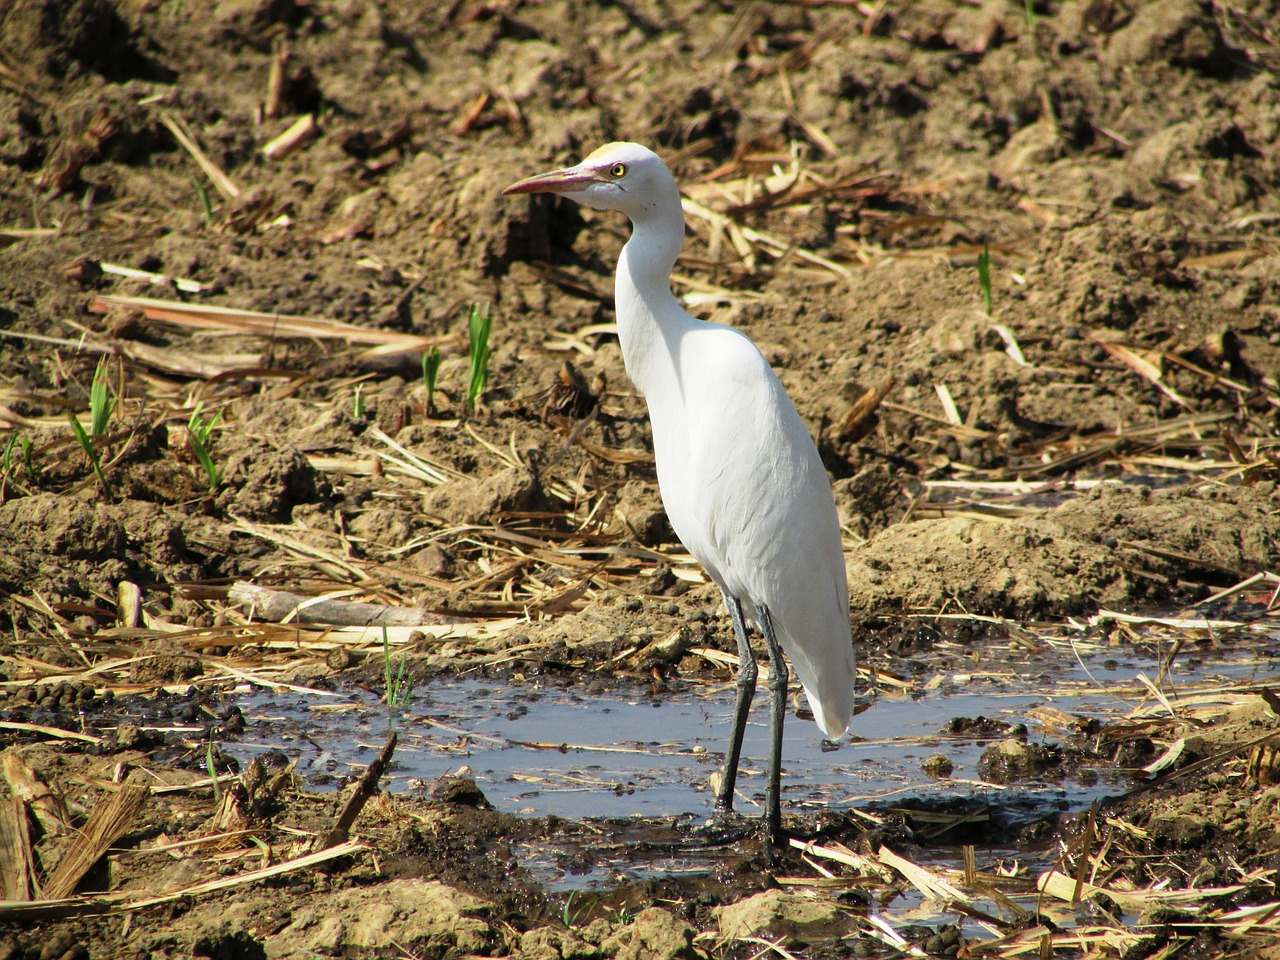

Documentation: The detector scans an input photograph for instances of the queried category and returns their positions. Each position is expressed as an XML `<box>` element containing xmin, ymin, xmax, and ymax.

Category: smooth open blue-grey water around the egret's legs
<box><xmin>227</xmin><ymin>680</ymin><xmax>1090</xmax><ymax>819</ymax></box>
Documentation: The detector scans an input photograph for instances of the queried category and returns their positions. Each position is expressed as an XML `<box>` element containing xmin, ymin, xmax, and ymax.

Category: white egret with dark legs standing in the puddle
<box><xmin>503</xmin><ymin>143</ymin><xmax>855</xmax><ymax>844</ymax></box>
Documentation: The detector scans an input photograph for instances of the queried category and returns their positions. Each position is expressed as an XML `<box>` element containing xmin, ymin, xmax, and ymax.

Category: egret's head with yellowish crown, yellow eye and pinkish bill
<box><xmin>503</xmin><ymin>143</ymin><xmax>680</xmax><ymax>220</ymax></box>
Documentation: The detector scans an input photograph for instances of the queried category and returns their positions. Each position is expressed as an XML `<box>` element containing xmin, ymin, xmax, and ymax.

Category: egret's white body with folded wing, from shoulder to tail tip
<box><xmin>649</xmin><ymin>324</ymin><xmax>854</xmax><ymax>736</ymax></box>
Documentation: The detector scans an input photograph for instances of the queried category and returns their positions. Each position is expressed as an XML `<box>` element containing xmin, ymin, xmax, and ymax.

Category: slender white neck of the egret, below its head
<box><xmin>614</xmin><ymin>204</ymin><xmax>694</xmax><ymax>394</ymax></box>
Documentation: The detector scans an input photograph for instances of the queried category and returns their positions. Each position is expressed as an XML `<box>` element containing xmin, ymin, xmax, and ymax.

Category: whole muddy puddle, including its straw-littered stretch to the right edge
<box><xmin>224</xmin><ymin>631</ymin><xmax>1280</xmax><ymax>888</ymax></box>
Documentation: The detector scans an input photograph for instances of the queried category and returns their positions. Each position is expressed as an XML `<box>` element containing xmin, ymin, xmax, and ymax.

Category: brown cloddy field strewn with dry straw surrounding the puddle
<box><xmin>0</xmin><ymin>0</ymin><xmax>1280</xmax><ymax>960</ymax></box>
